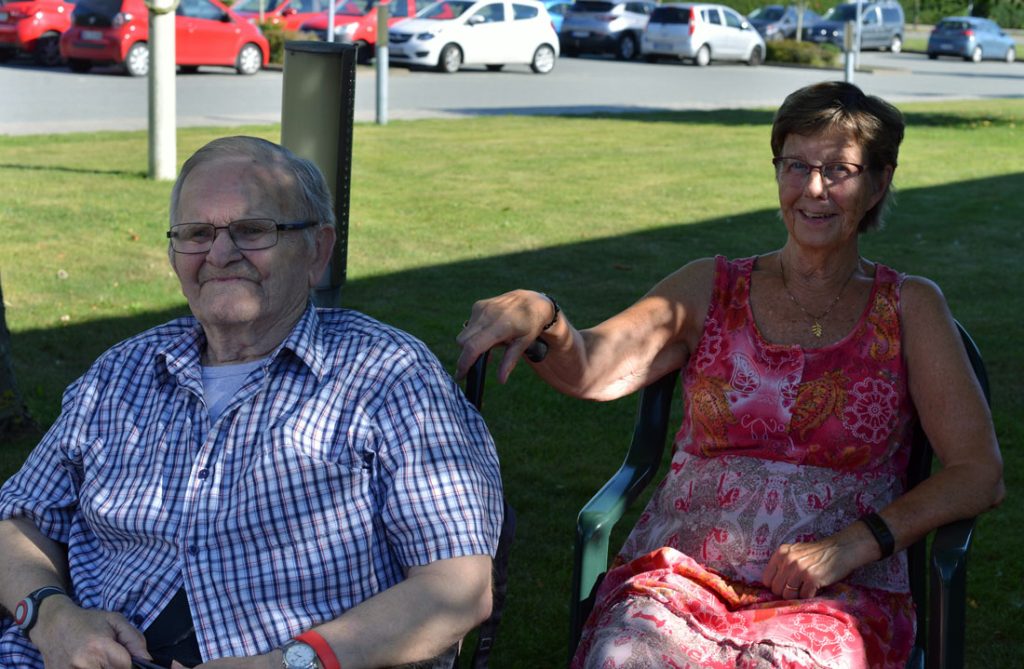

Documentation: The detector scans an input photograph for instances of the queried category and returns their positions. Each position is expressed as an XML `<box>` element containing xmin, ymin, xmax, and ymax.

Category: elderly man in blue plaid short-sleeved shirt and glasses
<box><xmin>0</xmin><ymin>137</ymin><xmax>502</xmax><ymax>669</ymax></box>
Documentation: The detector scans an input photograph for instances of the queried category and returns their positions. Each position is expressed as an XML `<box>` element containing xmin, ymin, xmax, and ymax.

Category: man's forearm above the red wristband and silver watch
<box><xmin>315</xmin><ymin>555</ymin><xmax>492</xmax><ymax>669</ymax></box>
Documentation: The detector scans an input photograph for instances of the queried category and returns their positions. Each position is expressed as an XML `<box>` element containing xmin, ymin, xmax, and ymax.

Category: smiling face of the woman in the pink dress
<box><xmin>776</xmin><ymin>132</ymin><xmax>892</xmax><ymax>247</ymax></box>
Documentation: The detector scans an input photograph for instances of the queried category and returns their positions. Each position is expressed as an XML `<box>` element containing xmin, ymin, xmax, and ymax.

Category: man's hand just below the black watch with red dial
<box><xmin>30</xmin><ymin>597</ymin><xmax>150</xmax><ymax>669</ymax></box>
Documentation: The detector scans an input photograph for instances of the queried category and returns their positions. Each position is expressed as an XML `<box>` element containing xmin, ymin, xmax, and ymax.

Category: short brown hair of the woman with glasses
<box><xmin>771</xmin><ymin>81</ymin><xmax>905</xmax><ymax>233</ymax></box>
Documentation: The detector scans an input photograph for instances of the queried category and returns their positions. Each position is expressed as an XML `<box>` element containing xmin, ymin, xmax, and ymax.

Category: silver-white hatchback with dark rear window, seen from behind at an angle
<box><xmin>640</xmin><ymin>3</ymin><xmax>765</xmax><ymax>67</ymax></box>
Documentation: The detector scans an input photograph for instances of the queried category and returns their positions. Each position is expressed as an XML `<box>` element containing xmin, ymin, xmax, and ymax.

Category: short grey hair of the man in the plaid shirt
<box><xmin>171</xmin><ymin>135</ymin><xmax>335</xmax><ymax>227</ymax></box>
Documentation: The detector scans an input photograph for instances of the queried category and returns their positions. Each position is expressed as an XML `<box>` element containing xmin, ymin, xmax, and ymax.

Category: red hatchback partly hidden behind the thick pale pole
<box><xmin>60</xmin><ymin>0</ymin><xmax>270</xmax><ymax>77</ymax></box>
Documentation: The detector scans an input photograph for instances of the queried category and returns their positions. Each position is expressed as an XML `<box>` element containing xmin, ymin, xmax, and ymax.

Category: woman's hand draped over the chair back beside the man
<box><xmin>456</xmin><ymin>290</ymin><xmax>555</xmax><ymax>383</ymax></box>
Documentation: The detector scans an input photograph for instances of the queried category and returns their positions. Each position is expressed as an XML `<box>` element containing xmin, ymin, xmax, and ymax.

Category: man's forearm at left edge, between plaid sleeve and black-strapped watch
<box><xmin>0</xmin><ymin>518</ymin><xmax>69</xmax><ymax>612</ymax></box>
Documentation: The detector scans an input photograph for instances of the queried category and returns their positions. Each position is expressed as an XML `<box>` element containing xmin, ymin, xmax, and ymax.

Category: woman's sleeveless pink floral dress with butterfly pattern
<box><xmin>573</xmin><ymin>257</ymin><xmax>914</xmax><ymax>669</ymax></box>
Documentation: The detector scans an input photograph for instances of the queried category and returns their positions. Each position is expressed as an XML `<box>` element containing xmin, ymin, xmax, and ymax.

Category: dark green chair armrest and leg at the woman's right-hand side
<box><xmin>927</xmin><ymin>518</ymin><xmax>975</xmax><ymax>668</ymax></box>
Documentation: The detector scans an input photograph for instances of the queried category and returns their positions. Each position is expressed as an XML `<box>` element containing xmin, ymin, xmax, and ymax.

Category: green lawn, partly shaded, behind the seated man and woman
<box><xmin>0</xmin><ymin>100</ymin><xmax>1024</xmax><ymax>668</ymax></box>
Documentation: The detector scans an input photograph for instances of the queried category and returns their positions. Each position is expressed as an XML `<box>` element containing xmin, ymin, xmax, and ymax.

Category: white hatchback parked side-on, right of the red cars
<box><xmin>388</xmin><ymin>0</ymin><xmax>558</xmax><ymax>75</ymax></box>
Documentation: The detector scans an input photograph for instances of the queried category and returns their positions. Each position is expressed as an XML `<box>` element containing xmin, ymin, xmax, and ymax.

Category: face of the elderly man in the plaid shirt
<box><xmin>170</xmin><ymin>157</ymin><xmax>334</xmax><ymax>345</ymax></box>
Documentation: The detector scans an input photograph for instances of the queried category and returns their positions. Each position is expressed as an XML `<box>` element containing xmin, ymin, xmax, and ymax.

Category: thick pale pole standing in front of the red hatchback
<box><xmin>147</xmin><ymin>0</ymin><xmax>178</xmax><ymax>180</ymax></box>
